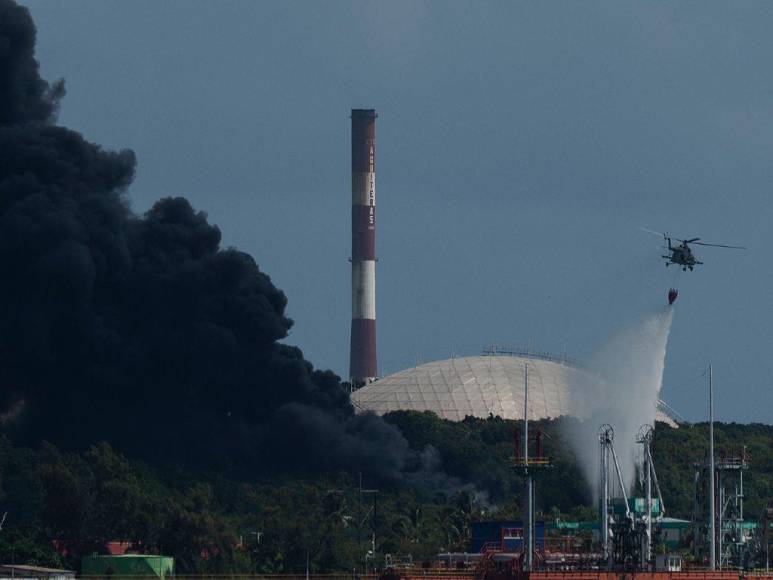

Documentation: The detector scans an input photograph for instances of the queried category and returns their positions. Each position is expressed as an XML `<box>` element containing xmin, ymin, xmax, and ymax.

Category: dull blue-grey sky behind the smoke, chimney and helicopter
<box><xmin>24</xmin><ymin>0</ymin><xmax>773</xmax><ymax>423</ymax></box>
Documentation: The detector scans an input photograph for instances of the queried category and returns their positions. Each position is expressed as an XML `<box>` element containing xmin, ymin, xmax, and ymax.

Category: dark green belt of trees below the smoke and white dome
<box><xmin>0</xmin><ymin>412</ymin><xmax>773</xmax><ymax>573</ymax></box>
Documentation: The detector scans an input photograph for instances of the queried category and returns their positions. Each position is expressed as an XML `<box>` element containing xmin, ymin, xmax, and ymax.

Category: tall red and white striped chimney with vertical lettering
<box><xmin>349</xmin><ymin>109</ymin><xmax>377</xmax><ymax>388</ymax></box>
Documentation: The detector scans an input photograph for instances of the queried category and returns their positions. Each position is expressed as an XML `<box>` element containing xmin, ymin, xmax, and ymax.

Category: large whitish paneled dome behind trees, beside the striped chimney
<box><xmin>352</xmin><ymin>356</ymin><xmax>675</xmax><ymax>425</ymax></box>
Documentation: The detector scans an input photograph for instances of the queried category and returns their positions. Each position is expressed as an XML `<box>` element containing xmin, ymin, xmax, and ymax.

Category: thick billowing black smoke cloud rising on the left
<box><xmin>0</xmin><ymin>0</ymin><xmax>416</xmax><ymax>478</ymax></box>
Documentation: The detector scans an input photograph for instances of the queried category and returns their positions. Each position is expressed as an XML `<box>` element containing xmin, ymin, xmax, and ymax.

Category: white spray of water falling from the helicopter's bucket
<box><xmin>567</xmin><ymin>307</ymin><xmax>673</xmax><ymax>501</ymax></box>
